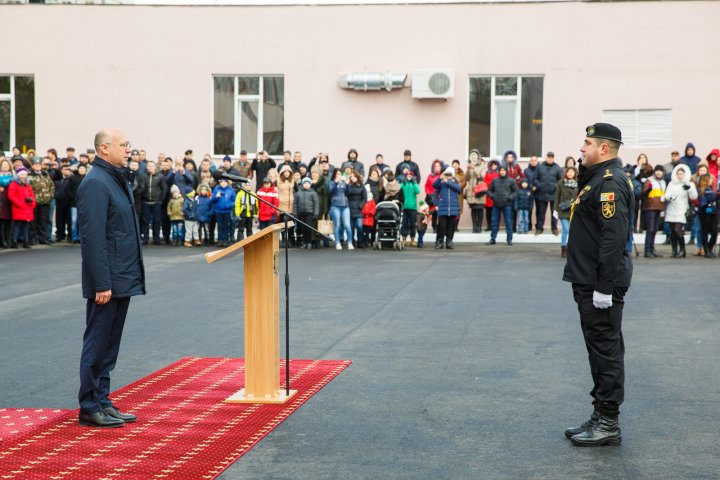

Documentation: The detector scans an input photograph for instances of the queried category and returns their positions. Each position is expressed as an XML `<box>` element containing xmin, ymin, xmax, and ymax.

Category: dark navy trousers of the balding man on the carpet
<box><xmin>78</xmin><ymin>297</ymin><xmax>130</xmax><ymax>413</ymax></box>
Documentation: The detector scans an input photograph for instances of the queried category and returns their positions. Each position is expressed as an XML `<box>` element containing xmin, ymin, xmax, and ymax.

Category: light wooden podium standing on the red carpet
<box><xmin>205</xmin><ymin>222</ymin><xmax>297</xmax><ymax>403</ymax></box>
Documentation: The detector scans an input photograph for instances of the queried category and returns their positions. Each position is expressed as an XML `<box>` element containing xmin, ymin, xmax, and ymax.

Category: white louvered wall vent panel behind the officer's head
<box><xmin>602</xmin><ymin>109</ymin><xmax>672</xmax><ymax>148</ymax></box>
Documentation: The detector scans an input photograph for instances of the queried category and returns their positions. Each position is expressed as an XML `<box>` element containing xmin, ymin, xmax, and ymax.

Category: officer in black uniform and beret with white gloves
<box><xmin>563</xmin><ymin>123</ymin><xmax>635</xmax><ymax>446</ymax></box>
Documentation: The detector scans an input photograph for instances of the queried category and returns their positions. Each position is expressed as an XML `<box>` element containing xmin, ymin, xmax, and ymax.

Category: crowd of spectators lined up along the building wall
<box><xmin>0</xmin><ymin>143</ymin><xmax>720</xmax><ymax>258</ymax></box>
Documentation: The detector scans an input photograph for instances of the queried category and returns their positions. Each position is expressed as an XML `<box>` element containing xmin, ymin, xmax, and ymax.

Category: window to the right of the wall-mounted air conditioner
<box><xmin>468</xmin><ymin>76</ymin><xmax>544</xmax><ymax>157</ymax></box>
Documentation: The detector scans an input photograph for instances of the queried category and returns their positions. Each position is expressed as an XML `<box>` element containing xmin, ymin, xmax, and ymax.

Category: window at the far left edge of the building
<box><xmin>0</xmin><ymin>75</ymin><xmax>35</xmax><ymax>154</ymax></box>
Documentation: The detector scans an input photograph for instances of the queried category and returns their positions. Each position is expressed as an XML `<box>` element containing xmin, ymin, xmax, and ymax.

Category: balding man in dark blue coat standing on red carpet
<box><xmin>78</xmin><ymin>129</ymin><xmax>145</xmax><ymax>427</ymax></box>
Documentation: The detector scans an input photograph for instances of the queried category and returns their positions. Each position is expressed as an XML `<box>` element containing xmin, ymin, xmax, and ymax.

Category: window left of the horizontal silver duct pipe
<box><xmin>213</xmin><ymin>75</ymin><xmax>285</xmax><ymax>156</ymax></box>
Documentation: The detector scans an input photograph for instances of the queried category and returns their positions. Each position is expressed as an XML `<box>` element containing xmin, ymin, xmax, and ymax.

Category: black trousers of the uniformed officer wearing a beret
<box><xmin>572</xmin><ymin>283</ymin><xmax>627</xmax><ymax>405</ymax></box>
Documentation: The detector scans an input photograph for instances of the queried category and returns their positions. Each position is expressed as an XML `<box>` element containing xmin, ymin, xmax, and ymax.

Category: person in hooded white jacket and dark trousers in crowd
<box><xmin>665</xmin><ymin>164</ymin><xmax>697</xmax><ymax>258</ymax></box>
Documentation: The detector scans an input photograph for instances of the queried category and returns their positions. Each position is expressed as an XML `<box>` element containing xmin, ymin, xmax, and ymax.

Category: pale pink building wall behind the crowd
<box><xmin>0</xmin><ymin>1</ymin><xmax>720</xmax><ymax>174</ymax></box>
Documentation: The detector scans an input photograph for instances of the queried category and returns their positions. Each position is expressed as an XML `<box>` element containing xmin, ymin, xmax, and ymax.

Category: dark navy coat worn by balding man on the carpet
<box><xmin>77</xmin><ymin>157</ymin><xmax>145</xmax><ymax>298</ymax></box>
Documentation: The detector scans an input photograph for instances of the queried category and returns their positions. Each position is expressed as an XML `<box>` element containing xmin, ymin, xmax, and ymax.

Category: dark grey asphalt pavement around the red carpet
<box><xmin>0</xmin><ymin>243</ymin><xmax>720</xmax><ymax>480</ymax></box>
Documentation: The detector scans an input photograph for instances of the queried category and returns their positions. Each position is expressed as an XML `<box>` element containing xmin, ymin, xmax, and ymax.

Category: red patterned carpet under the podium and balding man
<box><xmin>0</xmin><ymin>357</ymin><xmax>351</xmax><ymax>480</ymax></box>
